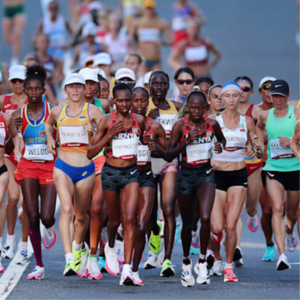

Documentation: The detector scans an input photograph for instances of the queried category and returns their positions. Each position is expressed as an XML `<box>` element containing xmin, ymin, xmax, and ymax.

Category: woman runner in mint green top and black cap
<box><xmin>257</xmin><ymin>80</ymin><xmax>300</xmax><ymax>271</ymax></box>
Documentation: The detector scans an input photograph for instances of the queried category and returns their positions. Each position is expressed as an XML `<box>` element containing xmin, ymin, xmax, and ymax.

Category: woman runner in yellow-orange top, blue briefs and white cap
<box><xmin>46</xmin><ymin>74</ymin><xmax>103</xmax><ymax>277</ymax></box>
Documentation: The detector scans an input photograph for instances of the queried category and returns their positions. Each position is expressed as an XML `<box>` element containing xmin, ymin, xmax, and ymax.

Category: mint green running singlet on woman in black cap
<box><xmin>264</xmin><ymin>105</ymin><xmax>300</xmax><ymax>172</ymax></box>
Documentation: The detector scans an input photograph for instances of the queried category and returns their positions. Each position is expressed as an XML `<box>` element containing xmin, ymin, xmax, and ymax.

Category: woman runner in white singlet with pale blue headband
<box><xmin>211</xmin><ymin>81</ymin><xmax>262</xmax><ymax>282</ymax></box>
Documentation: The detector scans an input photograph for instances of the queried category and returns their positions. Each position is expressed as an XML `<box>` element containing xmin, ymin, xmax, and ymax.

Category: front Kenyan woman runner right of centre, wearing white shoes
<box><xmin>166</xmin><ymin>87</ymin><xmax>226</xmax><ymax>287</ymax></box>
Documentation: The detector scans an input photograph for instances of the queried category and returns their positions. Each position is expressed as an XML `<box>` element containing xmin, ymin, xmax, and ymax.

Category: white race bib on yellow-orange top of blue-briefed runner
<box><xmin>59</xmin><ymin>126</ymin><xmax>89</xmax><ymax>147</ymax></box>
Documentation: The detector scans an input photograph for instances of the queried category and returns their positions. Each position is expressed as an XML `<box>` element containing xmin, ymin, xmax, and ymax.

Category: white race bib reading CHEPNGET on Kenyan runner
<box><xmin>112</xmin><ymin>136</ymin><xmax>139</xmax><ymax>160</ymax></box>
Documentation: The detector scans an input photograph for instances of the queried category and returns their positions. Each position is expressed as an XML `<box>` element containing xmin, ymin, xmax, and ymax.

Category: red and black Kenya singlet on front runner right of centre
<box><xmin>180</xmin><ymin>116</ymin><xmax>215</xmax><ymax>166</ymax></box>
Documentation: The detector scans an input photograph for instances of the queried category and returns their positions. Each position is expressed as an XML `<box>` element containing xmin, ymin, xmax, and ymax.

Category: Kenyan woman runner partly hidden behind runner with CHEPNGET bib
<box><xmin>132</xmin><ymin>87</ymin><xmax>167</xmax><ymax>285</ymax></box>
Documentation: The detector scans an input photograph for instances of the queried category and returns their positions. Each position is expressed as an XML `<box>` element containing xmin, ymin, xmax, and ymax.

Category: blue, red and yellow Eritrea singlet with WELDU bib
<box><xmin>20</xmin><ymin>102</ymin><xmax>56</xmax><ymax>163</ymax></box>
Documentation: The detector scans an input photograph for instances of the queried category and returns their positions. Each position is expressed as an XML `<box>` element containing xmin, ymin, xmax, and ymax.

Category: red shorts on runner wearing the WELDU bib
<box><xmin>15</xmin><ymin>158</ymin><xmax>54</xmax><ymax>184</ymax></box>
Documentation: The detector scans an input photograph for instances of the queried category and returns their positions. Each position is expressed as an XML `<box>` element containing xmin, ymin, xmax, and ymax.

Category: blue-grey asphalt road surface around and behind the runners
<box><xmin>0</xmin><ymin>0</ymin><xmax>300</xmax><ymax>300</ymax></box>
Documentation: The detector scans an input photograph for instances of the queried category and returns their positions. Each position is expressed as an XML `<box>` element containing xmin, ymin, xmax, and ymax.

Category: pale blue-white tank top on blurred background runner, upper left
<box><xmin>43</xmin><ymin>16</ymin><xmax>67</xmax><ymax>48</ymax></box>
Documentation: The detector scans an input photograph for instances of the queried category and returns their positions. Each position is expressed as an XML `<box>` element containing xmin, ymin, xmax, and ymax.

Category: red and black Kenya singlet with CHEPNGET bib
<box><xmin>104</xmin><ymin>113</ymin><xmax>141</xmax><ymax>160</ymax></box>
